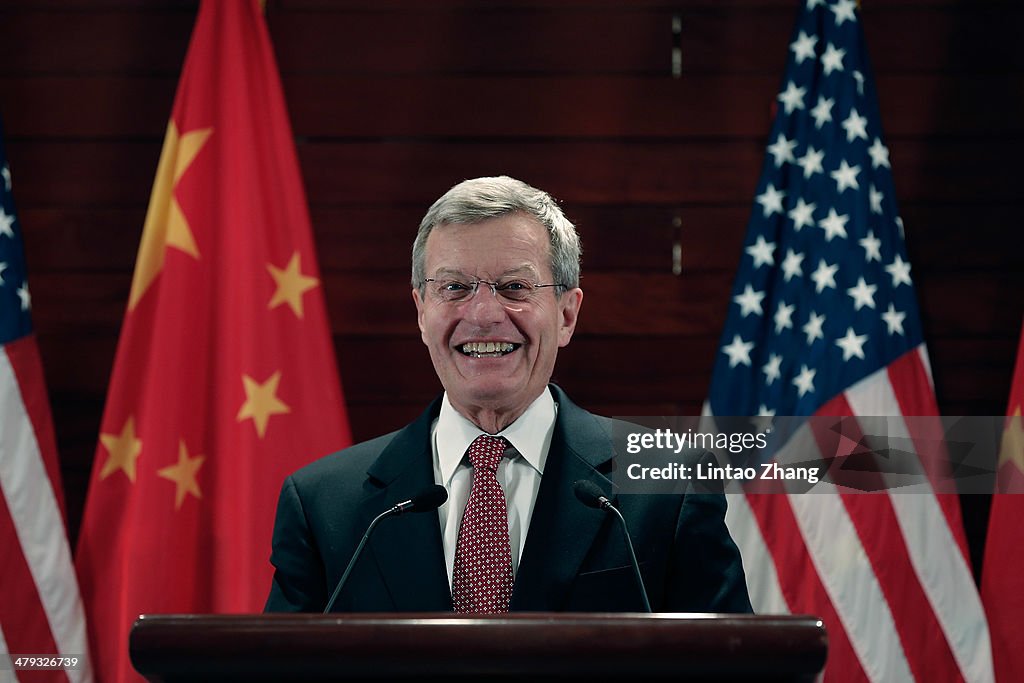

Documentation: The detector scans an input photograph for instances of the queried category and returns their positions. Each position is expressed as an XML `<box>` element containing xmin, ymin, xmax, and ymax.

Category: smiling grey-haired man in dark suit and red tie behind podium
<box><xmin>266</xmin><ymin>176</ymin><xmax>751</xmax><ymax>613</ymax></box>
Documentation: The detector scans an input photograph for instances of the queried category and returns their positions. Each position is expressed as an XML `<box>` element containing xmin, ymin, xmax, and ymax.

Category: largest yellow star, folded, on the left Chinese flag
<box><xmin>128</xmin><ymin>120</ymin><xmax>213</xmax><ymax>310</ymax></box>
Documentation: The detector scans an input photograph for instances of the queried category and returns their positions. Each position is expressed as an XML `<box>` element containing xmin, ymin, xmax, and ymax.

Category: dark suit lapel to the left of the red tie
<box><xmin>359</xmin><ymin>400</ymin><xmax>452</xmax><ymax>611</ymax></box>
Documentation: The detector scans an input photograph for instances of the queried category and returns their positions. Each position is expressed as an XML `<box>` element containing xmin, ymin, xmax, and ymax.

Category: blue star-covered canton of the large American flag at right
<box><xmin>709</xmin><ymin>0</ymin><xmax>922</xmax><ymax>416</ymax></box>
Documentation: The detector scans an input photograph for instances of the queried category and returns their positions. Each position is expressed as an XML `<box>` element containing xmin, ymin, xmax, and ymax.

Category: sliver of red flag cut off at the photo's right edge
<box><xmin>981</xmin><ymin>327</ymin><xmax>1024</xmax><ymax>681</ymax></box>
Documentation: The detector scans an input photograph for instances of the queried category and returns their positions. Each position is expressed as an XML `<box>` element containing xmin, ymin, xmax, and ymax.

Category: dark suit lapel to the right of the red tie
<box><xmin>511</xmin><ymin>385</ymin><xmax>613</xmax><ymax>611</ymax></box>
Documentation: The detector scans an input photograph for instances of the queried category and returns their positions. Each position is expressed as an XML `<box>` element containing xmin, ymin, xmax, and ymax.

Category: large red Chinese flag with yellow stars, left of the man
<box><xmin>76</xmin><ymin>0</ymin><xmax>350</xmax><ymax>682</ymax></box>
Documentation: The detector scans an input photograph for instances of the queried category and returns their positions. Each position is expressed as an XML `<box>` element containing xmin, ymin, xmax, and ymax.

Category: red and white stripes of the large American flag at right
<box><xmin>726</xmin><ymin>346</ymin><xmax>994</xmax><ymax>682</ymax></box>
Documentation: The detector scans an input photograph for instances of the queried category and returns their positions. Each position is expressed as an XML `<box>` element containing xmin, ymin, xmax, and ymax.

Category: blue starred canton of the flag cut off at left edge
<box><xmin>0</xmin><ymin>116</ymin><xmax>32</xmax><ymax>345</ymax></box>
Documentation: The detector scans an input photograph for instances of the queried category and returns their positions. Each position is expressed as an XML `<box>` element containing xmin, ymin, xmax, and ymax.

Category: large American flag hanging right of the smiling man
<box><xmin>707</xmin><ymin>0</ymin><xmax>992</xmax><ymax>681</ymax></box>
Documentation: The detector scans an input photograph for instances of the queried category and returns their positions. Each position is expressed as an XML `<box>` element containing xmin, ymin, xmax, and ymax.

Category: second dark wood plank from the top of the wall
<box><xmin>0</xmin><ymin>73</ymin><xmax>1024</xmax><ymax>140</ymax></box>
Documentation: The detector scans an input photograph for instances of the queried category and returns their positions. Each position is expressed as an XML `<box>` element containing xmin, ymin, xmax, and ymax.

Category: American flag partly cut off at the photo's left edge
<box><xmin>0</xmin><ymin>114</ymin><xmax>91</xmax><ymax>681</ymax></box>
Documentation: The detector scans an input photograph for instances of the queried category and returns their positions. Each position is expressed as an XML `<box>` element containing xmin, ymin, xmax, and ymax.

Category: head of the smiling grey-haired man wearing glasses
<box><xmin>413</xmin><ymin>201</ymin><xmax>583</xmax><ymax>434</ymax></box>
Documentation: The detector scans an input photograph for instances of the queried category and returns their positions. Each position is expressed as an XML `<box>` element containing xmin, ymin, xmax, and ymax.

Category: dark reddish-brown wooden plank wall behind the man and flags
<box><xmin>0</xmin><ymin>0</ymin><xmax>1024</xmax><ymax>581</ymax></box>
